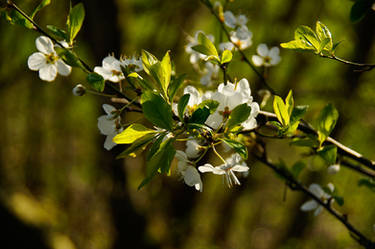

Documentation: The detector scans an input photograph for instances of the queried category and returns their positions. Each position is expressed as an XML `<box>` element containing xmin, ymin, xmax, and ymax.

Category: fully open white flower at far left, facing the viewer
<box><xmin>27</xmin><ymin>36</ymin><xmax>72</xmax><ymax>82</ymax></box>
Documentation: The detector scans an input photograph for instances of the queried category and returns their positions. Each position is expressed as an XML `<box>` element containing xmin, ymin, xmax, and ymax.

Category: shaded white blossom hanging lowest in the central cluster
<box><xmin>176</xmin><ymin>150</ymin><xmax>203</xmax><ymax>192</ymax></box>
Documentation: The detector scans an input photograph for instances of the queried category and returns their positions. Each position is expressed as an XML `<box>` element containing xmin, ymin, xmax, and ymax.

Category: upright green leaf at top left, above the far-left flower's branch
<box><xmin>67</xmin><ymin>3</ymin><xmax>85</xmax><ymax>44</ymax></box>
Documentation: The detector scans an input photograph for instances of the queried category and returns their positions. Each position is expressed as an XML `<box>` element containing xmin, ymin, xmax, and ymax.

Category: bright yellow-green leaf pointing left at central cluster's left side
<box><xmin>113</xmin><ymin>124</ymin><xmax>157</xmax><ymax>144</ymax></box>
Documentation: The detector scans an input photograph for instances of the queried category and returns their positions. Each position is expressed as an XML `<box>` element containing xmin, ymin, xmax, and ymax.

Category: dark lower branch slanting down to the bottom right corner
<box><xmin>255</xmin><ymin>155</ymin><xmax>375</xmax><ymax>249</ymax></box>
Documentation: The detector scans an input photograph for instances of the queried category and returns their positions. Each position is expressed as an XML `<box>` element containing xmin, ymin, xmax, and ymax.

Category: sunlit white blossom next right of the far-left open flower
<box><xmin>94</xmin><ymin>55</ymin><xmax>125</xmax><ymax>83</ymax></box>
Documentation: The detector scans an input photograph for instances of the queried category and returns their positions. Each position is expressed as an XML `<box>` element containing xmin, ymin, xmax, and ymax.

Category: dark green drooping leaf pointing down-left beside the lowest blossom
<box><xmin>138</xmin><ymin>138</ymin><xmax>176</xmax><ymax>190</ymax></box>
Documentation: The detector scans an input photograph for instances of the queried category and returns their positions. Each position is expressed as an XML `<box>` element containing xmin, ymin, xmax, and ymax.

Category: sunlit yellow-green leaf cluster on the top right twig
<box><xmin>280</xmin><ymin>21</ymin><xmax>340</xmax><ymax>56</ymax></box>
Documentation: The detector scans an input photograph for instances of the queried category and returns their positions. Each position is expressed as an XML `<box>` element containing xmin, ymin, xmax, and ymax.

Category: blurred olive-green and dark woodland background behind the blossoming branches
<box><xmin>0</xmin><ymin>0</ymin><xmax>375</xmax><ymax>249</ymax></box>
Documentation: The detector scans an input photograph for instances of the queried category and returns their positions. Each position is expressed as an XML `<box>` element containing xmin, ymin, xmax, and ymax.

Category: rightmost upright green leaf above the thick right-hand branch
<box><xmin>317</xmin><ymin>104</ymin><xmax>339</xmax><ymax>145</ymax></box>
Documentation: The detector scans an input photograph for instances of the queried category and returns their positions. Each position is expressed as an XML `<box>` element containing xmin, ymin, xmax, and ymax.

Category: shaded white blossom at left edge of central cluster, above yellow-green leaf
<box><xmin>98</xmin><ymin>104</ymin><xmax>123</xmax><ymax>150</ymax></box>
